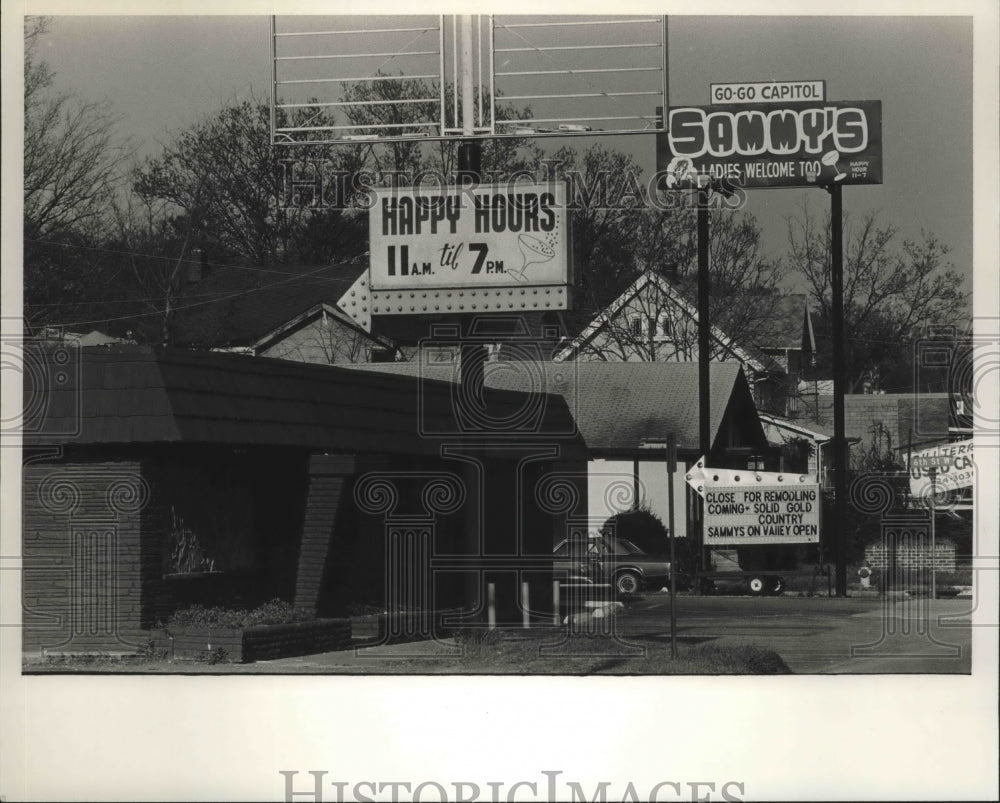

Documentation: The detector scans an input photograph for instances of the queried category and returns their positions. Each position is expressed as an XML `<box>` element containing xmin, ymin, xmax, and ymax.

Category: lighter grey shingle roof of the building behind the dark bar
<box><xmin>348</xmin><ymin>362</ymin><xmax>767</xmax><ymax>454</ymax></box>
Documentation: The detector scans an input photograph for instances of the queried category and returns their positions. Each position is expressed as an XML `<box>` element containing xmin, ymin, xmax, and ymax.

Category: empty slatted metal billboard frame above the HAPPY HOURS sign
<box><xmin>270</xmin><ymin>15</ymin><xmax>668</xmax><ymax>145</ymax></box>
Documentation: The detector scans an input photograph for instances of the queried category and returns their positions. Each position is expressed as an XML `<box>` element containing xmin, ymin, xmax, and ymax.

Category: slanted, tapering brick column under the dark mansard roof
<box><xmin>295</xmin><ymin>455</ymin><xmax>357</xmax><ymax>611</ymax></box>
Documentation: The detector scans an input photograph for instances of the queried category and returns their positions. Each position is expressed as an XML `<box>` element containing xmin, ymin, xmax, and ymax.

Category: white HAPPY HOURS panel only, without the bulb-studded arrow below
<box><xmin>369</xmin><ymin>182</ymin><xmax>569</xmax><ymax>291</ymax></box>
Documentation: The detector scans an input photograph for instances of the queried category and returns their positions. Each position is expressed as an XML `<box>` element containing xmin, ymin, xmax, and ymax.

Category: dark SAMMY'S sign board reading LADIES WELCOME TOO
<box><xmin>656</xmin><ymin>100</ymin><xmax>882</xmax><ymax>189</ymax></box>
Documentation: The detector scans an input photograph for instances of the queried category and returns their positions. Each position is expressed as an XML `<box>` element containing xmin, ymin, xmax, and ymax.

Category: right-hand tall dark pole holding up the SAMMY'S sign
<box><xmin>828</xmin><ymin>184</ymin><xmax>847</xmax><ymax>597</ymax></box>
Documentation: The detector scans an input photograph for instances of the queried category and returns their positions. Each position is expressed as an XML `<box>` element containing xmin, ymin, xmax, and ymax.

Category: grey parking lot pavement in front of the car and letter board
<box><xmin>617</xmin><ymin>594</ymin><xmax>972</xmax><ymax>674</ymax></box>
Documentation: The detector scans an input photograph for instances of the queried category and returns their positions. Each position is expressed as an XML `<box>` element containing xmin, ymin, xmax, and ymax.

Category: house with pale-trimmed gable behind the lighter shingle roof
<box><xmin>554</xmin><ymin>270</ymin><xmax>815</xmax><ymax>414</ymax></box>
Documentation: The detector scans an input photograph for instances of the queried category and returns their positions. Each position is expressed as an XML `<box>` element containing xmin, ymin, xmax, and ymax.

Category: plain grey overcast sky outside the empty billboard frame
<box><xmin>27</xmin><ymin>11</ymin><xmax>973</xmax><ymax>302</ymax></box>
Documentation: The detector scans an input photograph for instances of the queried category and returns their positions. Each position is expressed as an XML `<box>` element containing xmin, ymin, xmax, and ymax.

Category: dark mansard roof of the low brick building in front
<box><xmin>25</xmin><ymin>346</ymin><xmax>582</xmax><ymax>454</ymax></box>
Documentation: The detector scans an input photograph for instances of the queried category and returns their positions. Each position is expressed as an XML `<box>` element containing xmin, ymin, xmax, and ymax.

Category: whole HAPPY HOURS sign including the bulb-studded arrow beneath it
<box><xmin>338</xmin><ymin>181</ymin><xmax>573</xmax><ymax>331</ymax></box>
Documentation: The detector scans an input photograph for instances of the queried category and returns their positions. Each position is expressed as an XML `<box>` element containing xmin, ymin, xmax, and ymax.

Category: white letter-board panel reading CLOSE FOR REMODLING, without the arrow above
<box><xmin>705</xmin><ymin>483</ymin><xmax>821</xmax><ymax>546</ymax></box>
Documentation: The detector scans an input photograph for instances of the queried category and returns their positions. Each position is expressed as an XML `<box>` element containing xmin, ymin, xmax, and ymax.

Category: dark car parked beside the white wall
<box><xmin>552</xmin><ymin>533</ymin><xmax>680</xmax><ymax>594</ymax></box>
